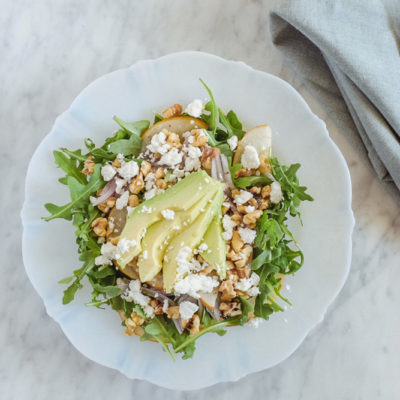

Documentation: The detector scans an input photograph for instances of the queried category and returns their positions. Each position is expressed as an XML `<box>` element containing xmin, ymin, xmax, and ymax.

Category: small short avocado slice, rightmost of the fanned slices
<box><xmin>200</xmin><ymin>214</ymin><xmax>226</xmax><ymax>279</ymax></box>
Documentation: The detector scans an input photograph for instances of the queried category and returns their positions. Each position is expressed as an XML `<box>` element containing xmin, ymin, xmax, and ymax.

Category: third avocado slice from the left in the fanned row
<box><xmin>163</xmin><ymin>184</ymin><xmax>224</xmax><ymax>293</ymax></box>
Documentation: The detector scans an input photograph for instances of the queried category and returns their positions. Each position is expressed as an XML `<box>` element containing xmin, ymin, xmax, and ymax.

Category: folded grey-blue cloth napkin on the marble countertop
<box><xmin>270</xmin><ymin>0</ymin><xmax>400</xmax><ymax>201</ymax></box>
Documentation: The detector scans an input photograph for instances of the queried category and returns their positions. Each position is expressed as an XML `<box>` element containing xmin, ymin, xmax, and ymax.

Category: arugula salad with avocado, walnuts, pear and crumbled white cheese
<box><xmin>44</xmin><ymin>80</ymin><xmax>313</xmax><ymax>359</ymax></box>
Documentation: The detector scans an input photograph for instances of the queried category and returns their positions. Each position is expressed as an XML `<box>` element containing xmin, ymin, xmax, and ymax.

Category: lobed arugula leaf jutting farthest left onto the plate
<box><xmin>44</xmin><ymin>164</ymin><xmax>104</xmax><ymax>221</ymax></box>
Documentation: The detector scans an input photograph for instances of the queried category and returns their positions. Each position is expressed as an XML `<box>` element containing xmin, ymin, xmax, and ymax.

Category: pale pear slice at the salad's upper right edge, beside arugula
<box><xmin>233</xmin><ymin>125</ymin><xmax>272</xmax><ymax>164</ymax></box>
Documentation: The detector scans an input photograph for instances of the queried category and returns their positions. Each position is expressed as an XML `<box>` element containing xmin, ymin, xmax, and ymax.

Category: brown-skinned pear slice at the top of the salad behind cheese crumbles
<box><xmin>142</xmin><ymin>116</ymin><xmax>208</xmax><ymax>149</ymax></box>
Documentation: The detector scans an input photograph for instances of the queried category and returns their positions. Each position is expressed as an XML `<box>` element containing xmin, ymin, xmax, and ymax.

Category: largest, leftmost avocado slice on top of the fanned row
<box><xmin>118</xmin><ymin>171</ymin><xmax>221</xmax><ymax>268</ymax></box>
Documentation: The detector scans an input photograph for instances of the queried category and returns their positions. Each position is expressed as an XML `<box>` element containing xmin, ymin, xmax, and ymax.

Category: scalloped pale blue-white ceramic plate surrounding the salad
<box><xmin>22</xmin><ymin>52</ymin><xmax>354</xmax><ymax>390</ymax></box>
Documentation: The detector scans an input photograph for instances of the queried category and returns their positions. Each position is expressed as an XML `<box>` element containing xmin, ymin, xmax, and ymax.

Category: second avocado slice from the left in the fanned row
<box><xmin>138</xmin><ymin>186</ymin><xmax>217</xmax><ymax>282</ymax></box>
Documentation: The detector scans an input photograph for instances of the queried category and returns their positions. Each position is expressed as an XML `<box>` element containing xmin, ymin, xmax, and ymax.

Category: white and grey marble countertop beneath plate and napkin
<box><xmin>0</xmin><ymin>0</ymin><xmax>400</xmax><ymax>400</ymax></box>
